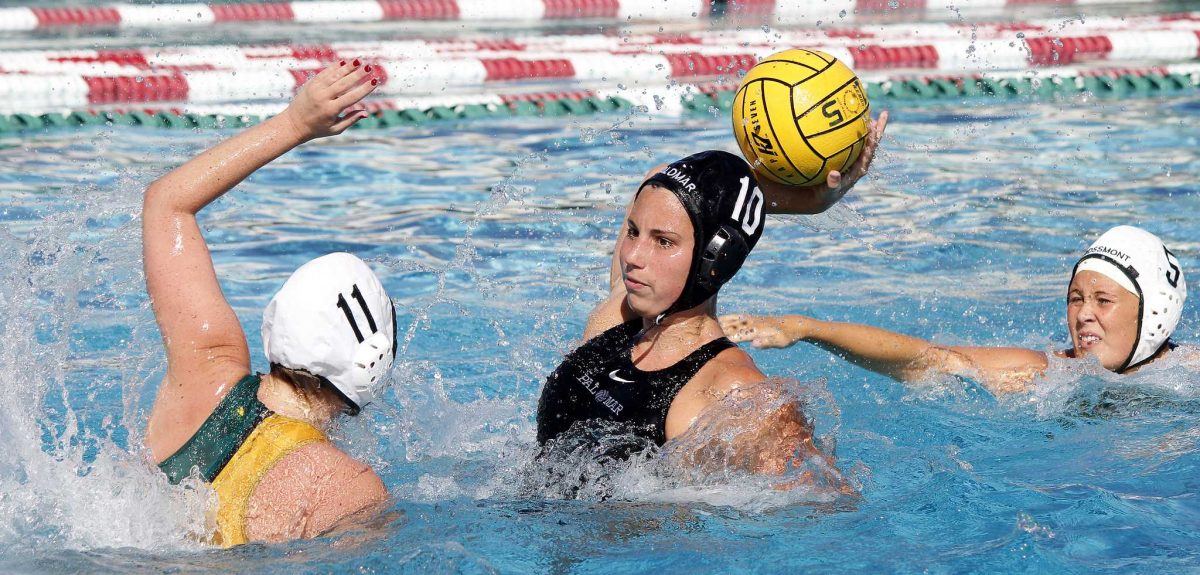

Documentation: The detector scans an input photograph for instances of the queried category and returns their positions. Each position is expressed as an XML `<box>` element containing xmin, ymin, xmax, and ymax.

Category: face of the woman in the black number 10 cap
<box><xmin>618</xmin><ymin>185</ymin><xmax>696</xmax><ymax>317</ymax></box>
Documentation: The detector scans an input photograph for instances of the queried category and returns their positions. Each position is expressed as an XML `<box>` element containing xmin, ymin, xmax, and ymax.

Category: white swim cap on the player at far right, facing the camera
<box><xmin>1070</xmin><ymin>226</ymin><xmax>1188</xmax><ymax>372</ymax></box>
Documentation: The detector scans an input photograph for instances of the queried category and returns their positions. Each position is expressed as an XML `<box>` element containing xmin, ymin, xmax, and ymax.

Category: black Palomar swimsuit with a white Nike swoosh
<box><xmin>538</xmin><ymin>319</ymin><xmax>734</xmax><ymax>445</ymax></box>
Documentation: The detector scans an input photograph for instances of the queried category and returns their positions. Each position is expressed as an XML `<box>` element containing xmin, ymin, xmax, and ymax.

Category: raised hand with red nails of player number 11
<box><xmin>282</xmin><ymin>60</ymin><xmax>378</xmax><ymax>142</ymax></box>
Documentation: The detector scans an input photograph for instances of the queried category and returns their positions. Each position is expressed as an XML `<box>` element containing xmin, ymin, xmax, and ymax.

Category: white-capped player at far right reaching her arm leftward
<box><xmin>721</xmin><ymin>226</ymin><xmax>1187</xmax><ymax>395</ymax></box>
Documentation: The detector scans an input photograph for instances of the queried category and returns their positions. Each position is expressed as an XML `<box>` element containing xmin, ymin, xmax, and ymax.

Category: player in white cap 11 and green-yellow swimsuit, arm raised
<box><xmin>142</xmin><ymin>60</ymin><xmax>396</xmax><ymax>546</ymax></box>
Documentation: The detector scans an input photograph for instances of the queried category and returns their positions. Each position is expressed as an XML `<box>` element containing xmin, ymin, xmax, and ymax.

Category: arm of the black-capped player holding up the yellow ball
<box><xmin>758</xmin><ymin>110</ymin><xmax>888</xmax><ymax>214</ymax></box>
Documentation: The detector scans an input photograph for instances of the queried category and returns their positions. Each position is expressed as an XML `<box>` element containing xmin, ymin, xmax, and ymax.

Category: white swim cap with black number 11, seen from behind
<box><xmin>263</xmin><ymin>253</ymin><xmax>396</xmax><ymax>414</ymax></box>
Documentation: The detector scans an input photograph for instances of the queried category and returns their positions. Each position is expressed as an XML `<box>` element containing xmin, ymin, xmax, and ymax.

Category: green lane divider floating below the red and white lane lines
<box><xmin>0</xmin><ymin>73</ymin><xmax>1200</xmax><ymax>134</ymax></box>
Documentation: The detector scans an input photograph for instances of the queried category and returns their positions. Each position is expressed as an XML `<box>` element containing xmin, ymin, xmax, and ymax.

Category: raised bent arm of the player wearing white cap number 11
<box><xmin>142</xmin><ymin>61</ymin><xmax>374</xmax><ymax>457</ymax></box>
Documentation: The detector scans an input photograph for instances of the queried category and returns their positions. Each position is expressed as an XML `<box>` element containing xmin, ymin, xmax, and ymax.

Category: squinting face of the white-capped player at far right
<box><xmin>1067</xmin><ymin>270</ymin><xmax>1139</xmax><ymax>370</ymax></box>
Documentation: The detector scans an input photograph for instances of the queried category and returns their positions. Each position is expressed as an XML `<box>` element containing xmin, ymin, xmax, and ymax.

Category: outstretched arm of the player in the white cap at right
<box><xmin>721</xmin><ymin>315</ymin><xmax>1048</xmax><ymax>395</ymax></box>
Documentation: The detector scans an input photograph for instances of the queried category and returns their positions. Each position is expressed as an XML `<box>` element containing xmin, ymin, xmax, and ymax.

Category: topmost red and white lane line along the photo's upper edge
<box><xmin>0</xmin><ymin>0</ymin><xmax>1180</xmax><ymax>30</ymax></box>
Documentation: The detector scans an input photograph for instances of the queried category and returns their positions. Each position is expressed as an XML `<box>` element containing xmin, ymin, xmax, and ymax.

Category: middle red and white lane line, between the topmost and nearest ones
<box><xmin>0</xmin><ymin>13</ymin><xmax>1200</xmax><ymax>74</ymax></box>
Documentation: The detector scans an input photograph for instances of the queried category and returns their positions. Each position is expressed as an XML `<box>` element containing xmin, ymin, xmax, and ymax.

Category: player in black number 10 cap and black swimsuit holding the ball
<box><xmin>538</xmin><ymin>112</ymin><xmax>886</xmax><ymax>472</ymax></box>
